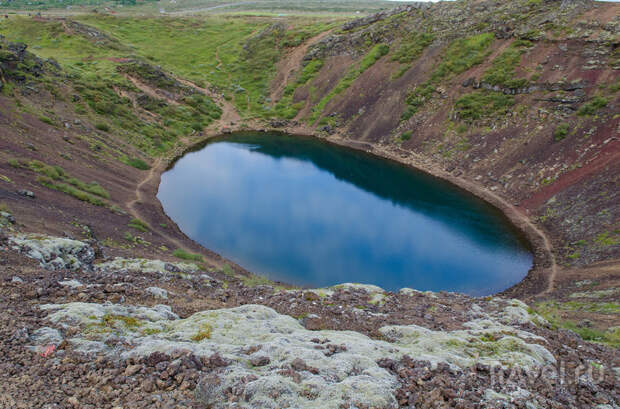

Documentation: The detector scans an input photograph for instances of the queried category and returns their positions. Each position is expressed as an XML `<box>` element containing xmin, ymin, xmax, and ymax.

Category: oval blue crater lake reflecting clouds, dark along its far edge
<box><xmin>158</xmin><ymin>133</ymin><xmax>532</xmax><ymax>295</ymax></box>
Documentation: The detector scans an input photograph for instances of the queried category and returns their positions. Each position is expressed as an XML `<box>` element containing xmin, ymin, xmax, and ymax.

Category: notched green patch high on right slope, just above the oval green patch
<box><xmin>482</xmin><ymin>40</ymin><xmax>532</xmax><ymax>88</ymax></box>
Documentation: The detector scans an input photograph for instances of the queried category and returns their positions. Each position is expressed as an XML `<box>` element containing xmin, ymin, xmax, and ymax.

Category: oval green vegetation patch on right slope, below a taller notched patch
<box><xmin>455</xmin><ymin>90</ymin><xmax>514</xmax><ymax>123</ymax></box>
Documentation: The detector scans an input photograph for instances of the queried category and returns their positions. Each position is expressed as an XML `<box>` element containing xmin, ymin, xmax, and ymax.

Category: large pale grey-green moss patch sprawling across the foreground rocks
<box><xmin>41</xmin><ymin>302</ymin><xmax>555</xmax><ymax>409</ymax></box>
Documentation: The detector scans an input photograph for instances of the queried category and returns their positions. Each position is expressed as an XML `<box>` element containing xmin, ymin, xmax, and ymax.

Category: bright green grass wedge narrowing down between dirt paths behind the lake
<box><xmin>81</xmin><ymin>16</ymin><xmax>334</xmax><ymax>117</ymax></box>
